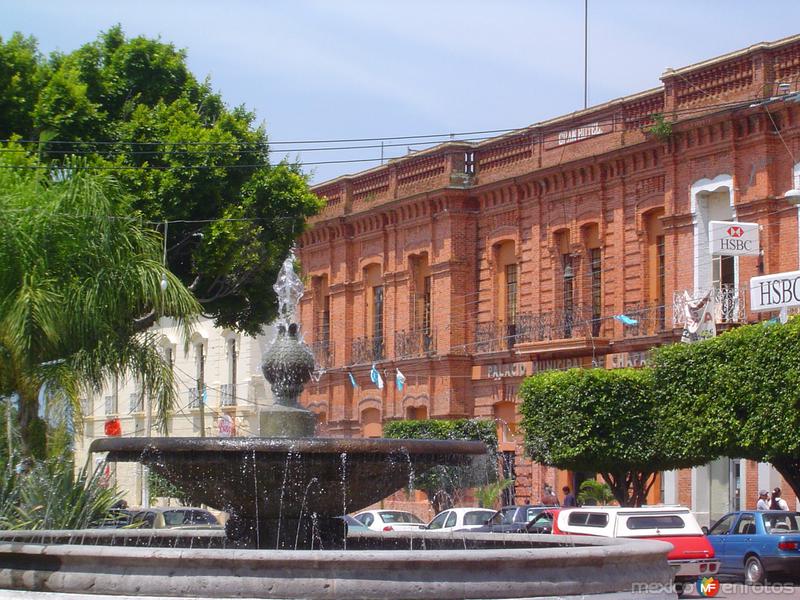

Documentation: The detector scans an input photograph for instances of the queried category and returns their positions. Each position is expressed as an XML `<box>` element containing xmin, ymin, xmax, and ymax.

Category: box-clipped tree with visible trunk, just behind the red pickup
<box><xmin>520</xmin><ymin>369</ymin><xmax>705</xmax><ymax>506</ymax></box>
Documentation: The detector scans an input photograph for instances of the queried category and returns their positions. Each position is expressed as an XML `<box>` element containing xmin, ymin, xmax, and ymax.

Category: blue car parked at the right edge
<box><xmin>707</xmin><ymin>511</ymin><xmax>800</xmax><ymax>584</ymax></box>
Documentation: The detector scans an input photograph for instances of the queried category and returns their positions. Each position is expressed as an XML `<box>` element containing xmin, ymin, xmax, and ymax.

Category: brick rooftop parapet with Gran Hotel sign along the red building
<box><xmin>312</xmin><ymin>35</ymin><xmax>800</xmax><ymax>222</ymax></box>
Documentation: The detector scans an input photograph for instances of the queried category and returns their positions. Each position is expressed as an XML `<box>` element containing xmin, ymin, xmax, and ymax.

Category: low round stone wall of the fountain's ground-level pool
<box><xmin>0</xmin><ymin>531</ymin><xmax>676</xmax><ymax>600</ymax></box>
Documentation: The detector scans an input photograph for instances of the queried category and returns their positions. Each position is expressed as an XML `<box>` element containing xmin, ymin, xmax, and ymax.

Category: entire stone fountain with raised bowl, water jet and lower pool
<box><xmin>0</xmin><ymin>256</ymin><xmax>675</xmax><ymax>600</ymax></box>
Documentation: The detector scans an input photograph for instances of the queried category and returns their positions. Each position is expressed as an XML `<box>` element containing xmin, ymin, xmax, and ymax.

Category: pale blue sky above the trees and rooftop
<box><xmin>0</xmin><ymin>0</ymin><xmax>800</xmax><ymax>182</ymax></box>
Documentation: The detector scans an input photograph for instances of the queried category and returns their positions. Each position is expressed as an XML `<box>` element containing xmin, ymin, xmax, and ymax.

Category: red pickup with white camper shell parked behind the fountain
<box><xmin>553</xmin><ymin>506</ymin><xmax>719</xmax><ymax>583</ymax></box>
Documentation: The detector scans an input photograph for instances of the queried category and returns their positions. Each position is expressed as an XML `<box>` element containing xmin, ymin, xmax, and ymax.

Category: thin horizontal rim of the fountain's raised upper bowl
<box><xmin>89</xmin><ymin>437</ymin><xmax>487</xmax><ymax>456</ymax></box>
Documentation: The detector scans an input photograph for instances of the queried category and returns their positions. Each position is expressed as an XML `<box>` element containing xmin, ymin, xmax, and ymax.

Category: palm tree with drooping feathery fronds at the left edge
<box><xmin>0</xmin><ymin>161</ymin><xmax>199</xmax><ymax>456</ymax></box>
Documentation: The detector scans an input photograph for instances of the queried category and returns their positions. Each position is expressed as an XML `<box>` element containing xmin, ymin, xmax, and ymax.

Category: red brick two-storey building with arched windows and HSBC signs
<box><xmin>299</xmin><ymin>36</ymin><xmax>800</xmax><ymax>518</ymax></box>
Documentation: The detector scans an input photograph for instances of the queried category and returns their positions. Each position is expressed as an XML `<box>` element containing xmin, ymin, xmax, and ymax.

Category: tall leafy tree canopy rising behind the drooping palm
<box><xmin>0</xmin><ymin>26</ymin><xmax>321</xmax><ymax>333</ymax></box>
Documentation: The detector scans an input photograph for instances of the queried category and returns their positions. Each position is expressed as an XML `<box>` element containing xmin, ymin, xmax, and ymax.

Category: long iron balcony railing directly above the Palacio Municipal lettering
<box><xmin>475</xmin><ymin>306</ymin><xmax>602</xmax><ymax>353</ymax></box>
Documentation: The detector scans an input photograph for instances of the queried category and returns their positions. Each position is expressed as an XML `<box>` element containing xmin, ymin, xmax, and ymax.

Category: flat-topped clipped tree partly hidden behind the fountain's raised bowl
<box><xmin>383</xmin><ymin>419</ymin><xmax>497</xmax><ymax>513</ymax></box>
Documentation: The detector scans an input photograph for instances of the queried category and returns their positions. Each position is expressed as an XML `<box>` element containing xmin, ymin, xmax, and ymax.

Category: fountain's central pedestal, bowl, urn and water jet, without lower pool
<box><xmin>90</xmin><ymin>255</ymin><xmax>486</xmax><ymax>548</ymax></box>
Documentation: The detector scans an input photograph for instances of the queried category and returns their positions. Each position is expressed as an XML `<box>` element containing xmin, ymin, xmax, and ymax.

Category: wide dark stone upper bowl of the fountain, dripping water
<box><xmin>89</xmin><ymin>437</ymin><xmax>486</xmax><ymax>519</ymax></box>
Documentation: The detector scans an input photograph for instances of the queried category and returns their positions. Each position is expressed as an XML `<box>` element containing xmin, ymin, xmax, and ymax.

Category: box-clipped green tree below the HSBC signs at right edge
<box><xmin>653</xmin><ymin>318</ymin><xmax>800</xmax><ymax>495</ymax></box>
